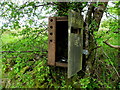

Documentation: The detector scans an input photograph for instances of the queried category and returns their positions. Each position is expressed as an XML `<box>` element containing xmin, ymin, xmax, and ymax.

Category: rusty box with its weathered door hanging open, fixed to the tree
<box><xmin>48</xmin><ymin>11</ymin><xmax>83</xmax><ymax>77</ymax></box>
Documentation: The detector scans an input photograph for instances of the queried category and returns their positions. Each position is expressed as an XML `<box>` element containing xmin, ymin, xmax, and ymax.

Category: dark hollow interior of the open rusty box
<box><xmin>56</xmin><ymin>21</ymin><xmax>68</xmax><ymax>63</ymax></box>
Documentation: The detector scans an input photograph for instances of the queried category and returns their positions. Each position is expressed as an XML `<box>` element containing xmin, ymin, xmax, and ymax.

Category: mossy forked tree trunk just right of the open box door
<box><xmin>85</xmin><ymin>2</ymin><xmax>107</xmax><ymax>76</ymax></box>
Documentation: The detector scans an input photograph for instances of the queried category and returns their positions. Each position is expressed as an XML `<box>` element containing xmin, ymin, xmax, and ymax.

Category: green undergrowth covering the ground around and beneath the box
<box><xmin>2</xmin><ymin>23</ymin><xmax>120</xmax><ymax>88</ymax></box>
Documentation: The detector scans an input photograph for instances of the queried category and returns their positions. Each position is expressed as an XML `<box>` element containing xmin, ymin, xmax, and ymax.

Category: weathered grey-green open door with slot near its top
<box><xmin>68</xmin><ymin>11</ymin><xmax>83</xmax><ymax>78</ymax></box>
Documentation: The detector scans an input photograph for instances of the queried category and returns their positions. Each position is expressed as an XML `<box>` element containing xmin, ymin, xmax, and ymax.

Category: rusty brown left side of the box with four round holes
<box><xmin>48</xmin><ymin>17</ymin><xmax>56</xmax><ymax>66</ymax></box>
